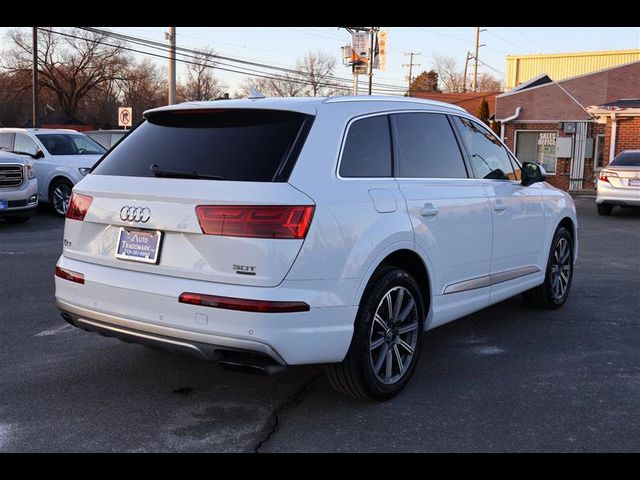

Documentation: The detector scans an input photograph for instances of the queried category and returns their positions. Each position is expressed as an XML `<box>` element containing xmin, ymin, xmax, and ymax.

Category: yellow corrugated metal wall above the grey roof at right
<box><xmin>505</xmin><ymin>49</ymin><xmax>640</xmax><ymax>91</ymax></box>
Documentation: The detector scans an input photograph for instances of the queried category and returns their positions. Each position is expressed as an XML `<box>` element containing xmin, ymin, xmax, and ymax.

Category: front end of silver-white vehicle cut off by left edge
<box><xmin>0</xmin><ymin>150</ymin><xmax>38</xmax><ymax>223</ymax></box>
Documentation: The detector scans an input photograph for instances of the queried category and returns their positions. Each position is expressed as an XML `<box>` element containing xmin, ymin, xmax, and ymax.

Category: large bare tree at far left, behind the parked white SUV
<box><xmin>3</xmin><ymin>29</ymin><xmax>130</xmax><ymax>119</ymax></box>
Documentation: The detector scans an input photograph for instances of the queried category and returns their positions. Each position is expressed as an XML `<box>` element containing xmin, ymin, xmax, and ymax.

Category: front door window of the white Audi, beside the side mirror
<box><xmin>454</xmin><ymin>117</ymin><xmax>516</xmax><ymax>180</ymax></box>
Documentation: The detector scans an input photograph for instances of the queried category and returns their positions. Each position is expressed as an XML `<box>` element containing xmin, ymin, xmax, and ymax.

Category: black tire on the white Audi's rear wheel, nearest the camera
<box><xmin>326</xmin><ymin>266</ymin><xmax>425</xmax><ymax>401</ymax></box>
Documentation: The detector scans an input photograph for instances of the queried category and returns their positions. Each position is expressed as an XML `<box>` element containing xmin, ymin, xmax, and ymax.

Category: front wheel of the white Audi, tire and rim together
<box><xmin>522</xmin><ymin>227</ymin><xmax>573</xmax><ymax>310</ymax></box>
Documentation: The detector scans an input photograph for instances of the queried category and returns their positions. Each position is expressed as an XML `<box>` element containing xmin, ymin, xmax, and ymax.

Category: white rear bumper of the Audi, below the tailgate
<box><xmin>55</xmin><ymin>256</ymin><xmax>358</xmax><ymax>365</ymax></box>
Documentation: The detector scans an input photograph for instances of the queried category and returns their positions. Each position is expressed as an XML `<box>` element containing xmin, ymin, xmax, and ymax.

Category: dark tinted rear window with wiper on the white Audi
<box><xmin>92</xmin><ymin>109</ymin><xmax>313</xmax><ymax>182</ymax></box>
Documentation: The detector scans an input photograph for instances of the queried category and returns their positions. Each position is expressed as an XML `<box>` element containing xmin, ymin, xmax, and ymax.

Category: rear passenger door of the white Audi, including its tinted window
<box><xmin>392</xmin><ymin>112</ymin><xmax>492</xmax><ymax>303</ymax></box>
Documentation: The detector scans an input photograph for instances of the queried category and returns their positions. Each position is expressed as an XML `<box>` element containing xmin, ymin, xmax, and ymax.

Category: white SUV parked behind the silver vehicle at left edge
<box><xmin>0</xmin><ymin>128</ymin><xmax>106</xmax><ymax>216</ymax></box>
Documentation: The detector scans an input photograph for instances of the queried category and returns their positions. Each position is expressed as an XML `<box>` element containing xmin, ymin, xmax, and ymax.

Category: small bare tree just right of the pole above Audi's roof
<box><xmin>178</xmin><ymin>48</ymin><xmax>227</xmax><ymax>101</ymax></box>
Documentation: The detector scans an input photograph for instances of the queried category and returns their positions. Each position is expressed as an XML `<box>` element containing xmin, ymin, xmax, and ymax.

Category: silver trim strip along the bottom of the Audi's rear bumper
<box><xmin>56</xmin><ymin>299</ymin><xmax>287</xmax><ymax>365</ymax></box>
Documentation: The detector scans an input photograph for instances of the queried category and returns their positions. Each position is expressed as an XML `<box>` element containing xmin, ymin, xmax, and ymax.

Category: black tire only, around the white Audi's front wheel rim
<box><xmin>522</xmin><ymin>227</ymin><xmax>573</xmax><ymax>310</ymax></box>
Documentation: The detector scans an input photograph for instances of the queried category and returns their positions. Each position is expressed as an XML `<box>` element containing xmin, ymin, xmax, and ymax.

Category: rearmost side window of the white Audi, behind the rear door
<box><xmin>340</xmin><ymin>115</ymin><xmax>391</xmax><ymax>177</ymax></box>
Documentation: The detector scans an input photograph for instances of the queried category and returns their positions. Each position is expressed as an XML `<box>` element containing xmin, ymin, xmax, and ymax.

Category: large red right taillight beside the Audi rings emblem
<box><xmin>196</xmin><ymin>205</ymin><xmax>314</xmax><ymax>239</ymax></box>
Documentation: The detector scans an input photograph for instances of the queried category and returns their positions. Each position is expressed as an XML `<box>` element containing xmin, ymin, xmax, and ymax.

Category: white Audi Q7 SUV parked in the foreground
<box><xmin>55</xmin><ymin>96</ymin><xmax>578</xmax><ymax>400</ymax></box>
